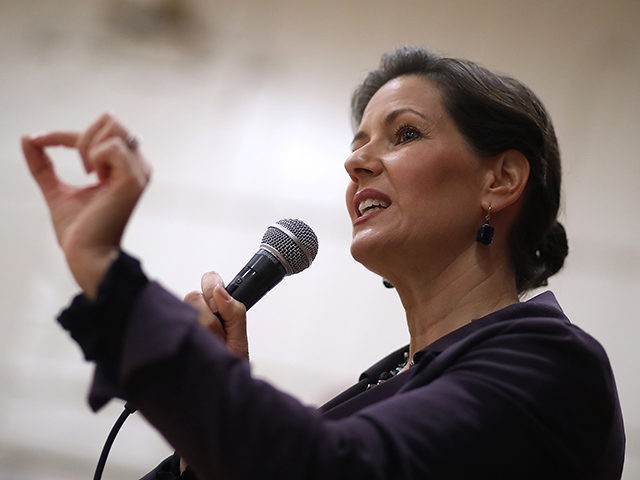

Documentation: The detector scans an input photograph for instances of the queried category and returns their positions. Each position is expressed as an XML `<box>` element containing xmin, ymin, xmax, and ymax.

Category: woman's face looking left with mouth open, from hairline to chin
<box><xmin>345</xmin><ymin>75</ymin><xmax>487</xmax><ymax>275</ymax></box>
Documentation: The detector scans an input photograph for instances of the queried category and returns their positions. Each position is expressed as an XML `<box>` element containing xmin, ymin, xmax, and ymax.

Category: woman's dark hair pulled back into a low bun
<box><xmin>351</xmin><ymin>47</ymin><xmax>568</xmax><ymax>293</ymax></box>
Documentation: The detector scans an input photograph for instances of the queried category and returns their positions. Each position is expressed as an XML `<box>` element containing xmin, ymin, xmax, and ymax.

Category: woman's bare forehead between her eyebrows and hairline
<box><xmin>361</xmin><ymin>75</ymin><xmax>444</xmax><ymax>123</ymax></box>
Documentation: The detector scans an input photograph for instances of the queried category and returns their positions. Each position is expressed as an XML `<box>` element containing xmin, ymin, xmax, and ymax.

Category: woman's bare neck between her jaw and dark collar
<box><xmin>393</xmin><ymin>246</ymin><xmax>518</xmax><ymax>360</ymax></box>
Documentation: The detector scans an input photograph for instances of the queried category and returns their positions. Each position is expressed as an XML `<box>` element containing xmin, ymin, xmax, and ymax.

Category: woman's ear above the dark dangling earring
<box><xmin>482</xmin><ymin>150</ymin><xmax>531</xmax><ymax>212</ymax></box>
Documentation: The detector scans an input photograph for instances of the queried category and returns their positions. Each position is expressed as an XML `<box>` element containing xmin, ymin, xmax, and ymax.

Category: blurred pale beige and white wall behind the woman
<box><xmin>0</xmin><ymin>0</ymin><xmax>640</xmax><ymax>480</ymax></box>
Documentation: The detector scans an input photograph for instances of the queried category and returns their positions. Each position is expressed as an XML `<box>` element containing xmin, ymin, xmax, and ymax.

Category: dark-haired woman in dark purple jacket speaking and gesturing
<box><xmin>23</xmin><ymin>48</ymin><xmax>624</xmax><ymax>479</ymax></box>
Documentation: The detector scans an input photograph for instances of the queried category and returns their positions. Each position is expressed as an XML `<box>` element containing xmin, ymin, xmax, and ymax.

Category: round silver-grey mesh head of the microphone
<box><xmin>260</xmin><ymin>218</ymin><xmax>318</xmax><ymax>275</ymax></box>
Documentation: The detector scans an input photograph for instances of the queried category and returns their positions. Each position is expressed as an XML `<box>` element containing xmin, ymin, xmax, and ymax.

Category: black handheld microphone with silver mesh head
<box><xmin>226</xmin><ymin>219</ymin><xmax>318</xmax><ymax>310</ymax></box>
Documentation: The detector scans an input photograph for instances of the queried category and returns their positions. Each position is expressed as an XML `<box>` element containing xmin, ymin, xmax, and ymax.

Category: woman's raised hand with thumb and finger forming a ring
<box><xmin>22</xmin><ymin>114</ymin><xmax>151</xmax><ymax>298</ymax></box>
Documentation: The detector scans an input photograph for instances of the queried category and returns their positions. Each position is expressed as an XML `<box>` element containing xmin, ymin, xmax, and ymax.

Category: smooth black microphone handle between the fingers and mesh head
<box><xmin>226</xmin><ymin>248</ymin><xmax>286</xmax><ymax>310</ymax></box>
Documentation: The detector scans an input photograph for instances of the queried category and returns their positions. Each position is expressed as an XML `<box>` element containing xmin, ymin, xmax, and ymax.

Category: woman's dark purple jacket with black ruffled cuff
<box><xmin>60</xmin><ymin>254</ymin><xmax>625</xmax><ymax>480</ymax></box>
